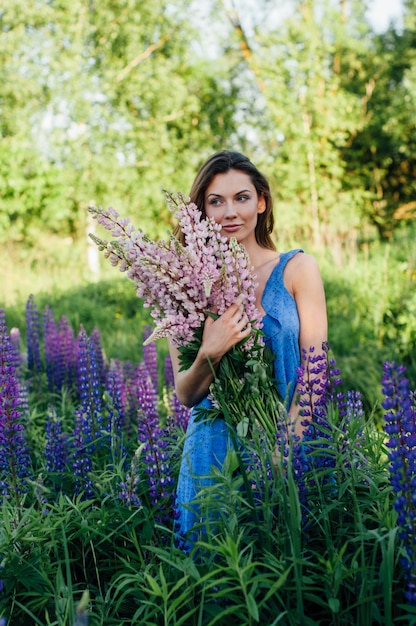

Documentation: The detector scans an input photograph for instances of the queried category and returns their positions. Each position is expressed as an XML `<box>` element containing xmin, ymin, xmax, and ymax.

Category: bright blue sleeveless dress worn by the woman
<box><xmin>176</xmin><ymin>249</ymin><xmax>303</xmax><ymax>536</ymax></box>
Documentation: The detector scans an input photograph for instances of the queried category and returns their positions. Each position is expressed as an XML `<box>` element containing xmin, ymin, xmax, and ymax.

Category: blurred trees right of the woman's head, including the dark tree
<box><xmin>206</xmin><ymin>0</ymin><xmax>415</xmax><ymax>249</ymax></box>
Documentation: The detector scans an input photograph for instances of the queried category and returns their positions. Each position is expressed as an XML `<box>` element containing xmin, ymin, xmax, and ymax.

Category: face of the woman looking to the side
<box><xmin>204</xmin><ymin>170</ymin><xmax>266</xmax><ymax>247</ymax></box>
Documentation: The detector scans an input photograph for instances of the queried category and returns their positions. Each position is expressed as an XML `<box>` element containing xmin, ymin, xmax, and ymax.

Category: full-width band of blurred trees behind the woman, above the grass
<box><xmin>0</xmin><ymin>0</ymin><xmax>416</xmax><ymax>247</ymax></box>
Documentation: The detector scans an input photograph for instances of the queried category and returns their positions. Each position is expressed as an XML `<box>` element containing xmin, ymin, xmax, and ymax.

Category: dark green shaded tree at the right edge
<box><xmin>343</xmin><ymin>24</ymin><xmax>416</xmax><ymax>239</ymax></box>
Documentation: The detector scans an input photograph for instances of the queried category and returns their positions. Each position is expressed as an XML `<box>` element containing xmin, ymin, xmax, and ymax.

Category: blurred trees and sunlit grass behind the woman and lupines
<box><xmin>0</xmin><ymin>0</ymin><xmax>416</xmax><ymax>402</ymax></box>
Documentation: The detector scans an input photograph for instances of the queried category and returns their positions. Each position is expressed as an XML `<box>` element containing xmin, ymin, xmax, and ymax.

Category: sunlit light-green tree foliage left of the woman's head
<box><xmin>0</xmin><ymin>0</ymin><xmax>239</xmax><ymax>239</ymax></box>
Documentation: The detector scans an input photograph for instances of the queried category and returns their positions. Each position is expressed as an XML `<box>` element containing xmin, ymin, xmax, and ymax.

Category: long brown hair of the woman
<box><xmin>175</xmin><ymin>150</ymin><xmax>276</xmax><ymax>250</ymax></box>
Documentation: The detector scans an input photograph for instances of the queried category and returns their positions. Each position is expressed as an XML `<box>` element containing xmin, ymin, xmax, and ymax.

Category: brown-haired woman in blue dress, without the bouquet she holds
<box><xmin>170</xmin><ymin>151</ymin><xmax>327</xmax><ymax>535</ymax></box>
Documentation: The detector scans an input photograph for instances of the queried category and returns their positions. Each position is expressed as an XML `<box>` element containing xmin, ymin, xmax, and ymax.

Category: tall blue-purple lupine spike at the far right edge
<box><xmin>382</xmin><ymin>362</ymin><xmax>416</xmax><ymax>606</ymax></box>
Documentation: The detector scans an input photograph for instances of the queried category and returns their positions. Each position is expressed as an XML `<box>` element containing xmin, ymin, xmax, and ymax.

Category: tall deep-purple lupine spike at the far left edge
<box><xmin>0</xmin><ymin>309</ymin><xmax>32</xmax><ymax>499</ymax></box>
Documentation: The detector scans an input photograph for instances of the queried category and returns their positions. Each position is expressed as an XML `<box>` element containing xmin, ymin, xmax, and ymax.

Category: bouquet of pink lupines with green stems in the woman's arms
<box><xmin>88</xmin><ymin>192</ymin><xmax>283</xmax><ymax>440</ymax></box>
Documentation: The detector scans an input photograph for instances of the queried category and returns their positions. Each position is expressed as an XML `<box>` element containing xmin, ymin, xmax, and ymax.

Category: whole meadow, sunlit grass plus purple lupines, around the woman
<box><xmin>0</xmin><ymin>225</ymin><xmax>416</xmax><ymax>626</ymax></box>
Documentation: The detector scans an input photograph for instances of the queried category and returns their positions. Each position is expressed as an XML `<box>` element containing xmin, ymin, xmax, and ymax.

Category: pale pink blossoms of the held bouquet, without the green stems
<box><xmin>89</xmin><ymin>193</ymin><xmax>261</xmax><ymax>349</ymax></box>
